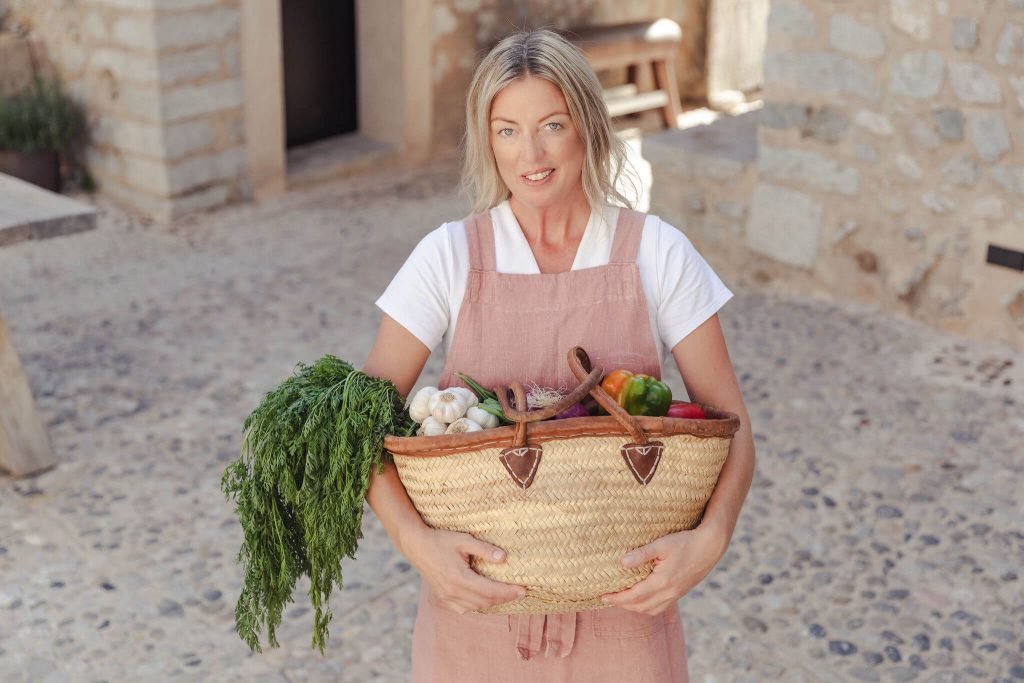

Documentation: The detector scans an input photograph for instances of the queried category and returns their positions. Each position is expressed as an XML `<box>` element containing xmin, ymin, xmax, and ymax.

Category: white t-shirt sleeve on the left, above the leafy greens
<box><xmin>376</xmin><ymin>224</ymin><xmax>452</xmax><ymax>351</ymax></box>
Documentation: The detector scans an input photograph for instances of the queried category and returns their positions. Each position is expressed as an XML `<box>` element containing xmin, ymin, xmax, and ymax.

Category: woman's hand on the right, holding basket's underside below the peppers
<box><xmin>601</xmin><ymin>522</ymin><xmax>729</xmax><ymax>615</ymax></box>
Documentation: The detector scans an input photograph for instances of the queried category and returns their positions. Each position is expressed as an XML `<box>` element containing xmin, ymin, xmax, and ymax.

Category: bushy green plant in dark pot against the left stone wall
<box><xmin>0</xmin><ymin>77</ymin><xmax>85</xmax><ymax>191</ymax></box>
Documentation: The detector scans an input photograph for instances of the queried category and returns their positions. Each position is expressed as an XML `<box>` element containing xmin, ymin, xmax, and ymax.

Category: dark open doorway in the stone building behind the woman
<box><xmin>281</xmin><ymin>0</ymin><xmax>358</xmax><ymax>147</ymax></box>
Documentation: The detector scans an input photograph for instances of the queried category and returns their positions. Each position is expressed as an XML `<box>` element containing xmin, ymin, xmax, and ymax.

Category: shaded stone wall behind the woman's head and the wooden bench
<box><xmin>431</xmin><ymin>0</ymin><xmax>707</xmax><ymax>148</ymax></box>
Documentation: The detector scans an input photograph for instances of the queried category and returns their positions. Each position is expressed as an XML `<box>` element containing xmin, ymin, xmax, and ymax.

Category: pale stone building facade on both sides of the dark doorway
<box><xmin>0</xmin><ymin>0</ymin><xmax>705</xmax><ymax>219</ymax></box>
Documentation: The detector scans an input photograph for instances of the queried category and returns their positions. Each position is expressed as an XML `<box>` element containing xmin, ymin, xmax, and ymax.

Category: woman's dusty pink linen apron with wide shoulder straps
<box><xmin>413</xmin><ymin>209</ymin><xmax>689</xmax><ymax>683</ymax></box>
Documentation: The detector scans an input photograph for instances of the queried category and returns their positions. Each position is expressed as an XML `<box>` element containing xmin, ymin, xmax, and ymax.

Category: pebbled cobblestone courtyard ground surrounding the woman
<box><xmin>0</xmin><ymin>164</ymin><xmax>1024</xmax><ymax>683</ymax></box>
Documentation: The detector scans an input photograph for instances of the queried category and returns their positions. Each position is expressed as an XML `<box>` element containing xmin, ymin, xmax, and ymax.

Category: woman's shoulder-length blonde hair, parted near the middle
<box><xmin>462</xmin><ymin>29</ymin><xmax>636</xmax><ymax>213</ymax></box>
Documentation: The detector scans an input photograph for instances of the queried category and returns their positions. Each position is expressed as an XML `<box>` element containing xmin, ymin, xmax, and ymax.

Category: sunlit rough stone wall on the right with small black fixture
<box><xmin>746</xmin><ymin>0</ymin><xmax>1024</xmax><ymax>344</ymax></box>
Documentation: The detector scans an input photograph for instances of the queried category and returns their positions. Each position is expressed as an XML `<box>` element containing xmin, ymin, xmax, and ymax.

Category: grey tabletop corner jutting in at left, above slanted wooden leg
<box><xmin>0</xmin><ymin>173</ymin><xmax>96</xmax><ymax>247</ymax></box>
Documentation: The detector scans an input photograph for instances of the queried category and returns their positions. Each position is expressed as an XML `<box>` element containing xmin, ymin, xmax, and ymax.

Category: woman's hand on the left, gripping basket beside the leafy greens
<box><xmin>402</xmin><ymin>525</ymin><xmax>526</xmax><ymax>614</ymax></box>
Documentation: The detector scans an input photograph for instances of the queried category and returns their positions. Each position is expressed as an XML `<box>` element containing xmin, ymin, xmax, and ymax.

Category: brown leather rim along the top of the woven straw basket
<box><xmin>384</xmin><ymin>401</ymin><xmax>740</xmax><ymax>458</ymax></box>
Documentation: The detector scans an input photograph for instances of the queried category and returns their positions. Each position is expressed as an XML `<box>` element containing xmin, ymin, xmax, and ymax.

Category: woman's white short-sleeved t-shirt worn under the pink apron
<box><xmin>377</xmin><ymin>201</ymin><xmax>732</xmax><ymax>367</ymax></box>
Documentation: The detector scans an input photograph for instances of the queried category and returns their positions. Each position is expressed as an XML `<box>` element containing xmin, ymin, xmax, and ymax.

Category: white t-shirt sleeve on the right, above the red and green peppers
<box><xmin>657</xmin><ymin>220</ymin><xmax>732</xmax><ymax>351</ymax></box>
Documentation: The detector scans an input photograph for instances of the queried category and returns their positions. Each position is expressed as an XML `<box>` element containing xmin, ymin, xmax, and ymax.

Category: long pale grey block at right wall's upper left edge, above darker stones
<box><xmin>764</xmin><ymin>51</ymin><xmax>880</xmax><ymax>100</ymax></box>
